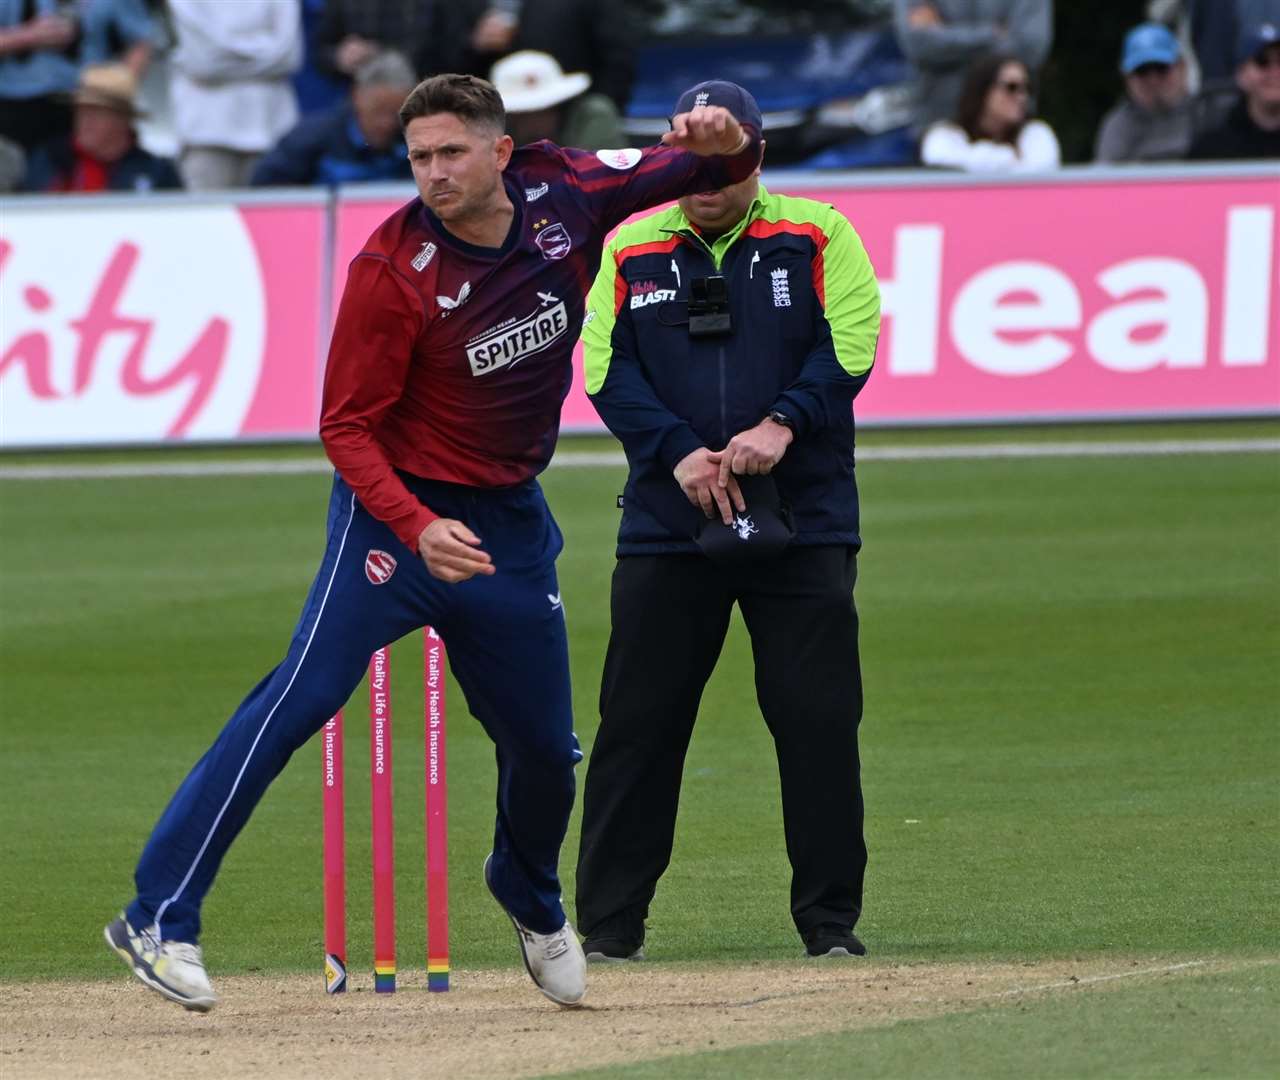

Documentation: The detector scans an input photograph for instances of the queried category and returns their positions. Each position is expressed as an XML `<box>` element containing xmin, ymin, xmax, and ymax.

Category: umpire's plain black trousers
<box><xmin>577</xmin><ymin>546</ymin><xmax>867</xmax><ymax>937</ymax></box>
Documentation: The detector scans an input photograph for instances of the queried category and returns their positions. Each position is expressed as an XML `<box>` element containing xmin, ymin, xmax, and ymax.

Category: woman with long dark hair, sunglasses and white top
<box><xmin>920</xmin><ymin>56</ymin><xmax>1061</xmax><ymax>173</ymax></box>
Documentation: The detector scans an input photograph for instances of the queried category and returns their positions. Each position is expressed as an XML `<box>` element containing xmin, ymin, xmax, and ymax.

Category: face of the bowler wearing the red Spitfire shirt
<box><xmin>404</xmin><ymin>113</ymin><xmax>512</xmax><ymax>221</ymax></box>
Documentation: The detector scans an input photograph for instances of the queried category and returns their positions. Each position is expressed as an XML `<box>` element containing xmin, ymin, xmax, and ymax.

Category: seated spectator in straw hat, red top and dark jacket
<box><xmin>24</xmin><ymin>64</ymin><xmax>182</xmax><ymax>192</ymax></box>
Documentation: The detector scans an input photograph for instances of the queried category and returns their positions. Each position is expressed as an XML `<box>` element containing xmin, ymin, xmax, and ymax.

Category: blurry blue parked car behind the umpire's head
<box><xmin>623</xmin><ymin>0</ymin><xmax>915</xmax><ymax>169</ymax></box>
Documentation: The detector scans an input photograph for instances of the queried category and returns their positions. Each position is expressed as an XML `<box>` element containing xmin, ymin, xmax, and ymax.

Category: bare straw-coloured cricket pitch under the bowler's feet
<box><xmin>0</xmin><ymin>957</ymin><xmax>1230</xmax><ymax>1080</ymax></box>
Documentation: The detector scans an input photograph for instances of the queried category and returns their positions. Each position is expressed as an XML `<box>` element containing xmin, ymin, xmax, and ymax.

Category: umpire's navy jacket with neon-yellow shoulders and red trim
<box><xmin>582</xmin><ymin>184</ymin><xmax>879</xmax><ymax>555</ymax></box>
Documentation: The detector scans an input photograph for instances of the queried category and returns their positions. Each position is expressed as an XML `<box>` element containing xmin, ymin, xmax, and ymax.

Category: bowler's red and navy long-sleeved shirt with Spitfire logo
<box><xmin>320</xmin><ymin>133</ymin><xmax>760</xmax><ymax>550</ymax></box>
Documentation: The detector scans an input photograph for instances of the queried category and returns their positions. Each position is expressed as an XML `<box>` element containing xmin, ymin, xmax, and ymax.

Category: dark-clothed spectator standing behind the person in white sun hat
<box><xmin>453</xmin><ymin>0</ymin><xmax>636</xmax><ymax>110</ymax></box>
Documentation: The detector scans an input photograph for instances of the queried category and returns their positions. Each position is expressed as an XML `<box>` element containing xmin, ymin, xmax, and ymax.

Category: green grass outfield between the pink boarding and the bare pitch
<box><xmin>0</xmin><ymin>422</ymin><xmax>1280</xmax><ymax>1075</ymax></box>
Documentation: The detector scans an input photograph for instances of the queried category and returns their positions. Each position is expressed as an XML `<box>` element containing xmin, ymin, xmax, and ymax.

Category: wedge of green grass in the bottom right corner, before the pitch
<box><xmin>557</xmin><ymin>960</ymin><xmax>1280</xmax><ymax>1080</ymax></box>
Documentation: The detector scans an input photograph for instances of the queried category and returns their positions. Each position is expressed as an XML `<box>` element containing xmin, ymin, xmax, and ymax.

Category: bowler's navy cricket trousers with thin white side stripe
<box><xmin>127</xmin><ymin>473</ymin><xmax>582</xmax><ymax>942</ymax></box>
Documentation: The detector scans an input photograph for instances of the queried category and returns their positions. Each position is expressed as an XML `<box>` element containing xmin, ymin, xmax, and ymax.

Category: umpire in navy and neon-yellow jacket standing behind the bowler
<box><xmin>577</xmin><ymin>81</ymin><xmax>879</xmax><ymax>960</ymax></box>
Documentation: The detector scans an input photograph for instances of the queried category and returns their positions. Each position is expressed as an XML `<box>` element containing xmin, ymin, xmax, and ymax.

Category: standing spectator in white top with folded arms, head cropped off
<box><xmin>169</xmin><ymin>0</ymin><xmax>302</xmax><ymax>191</ymax></box>
